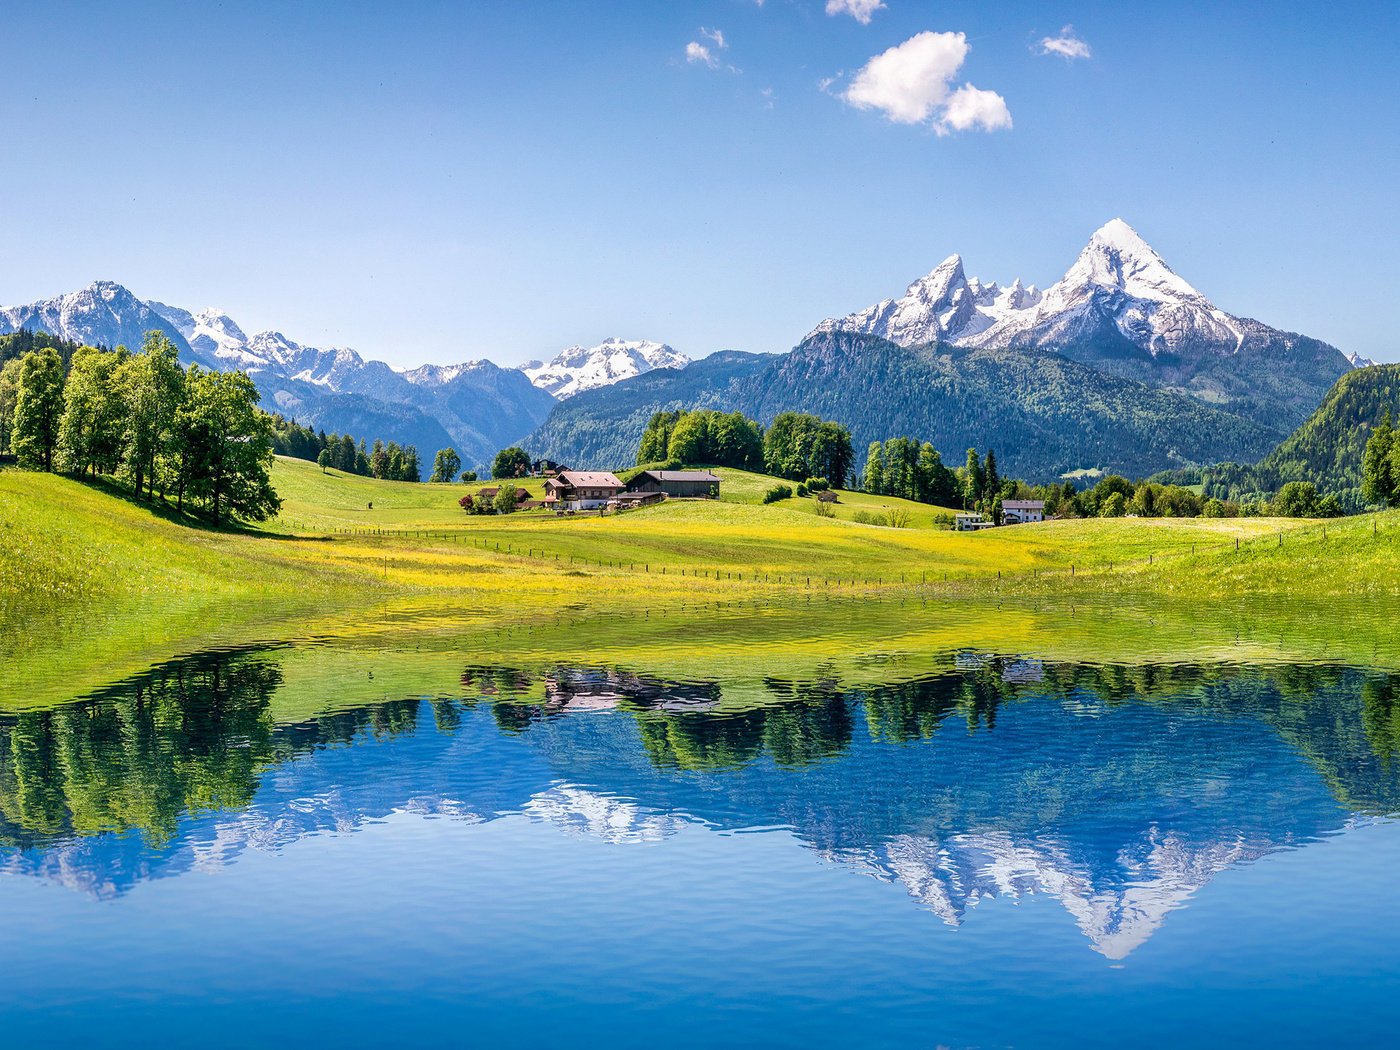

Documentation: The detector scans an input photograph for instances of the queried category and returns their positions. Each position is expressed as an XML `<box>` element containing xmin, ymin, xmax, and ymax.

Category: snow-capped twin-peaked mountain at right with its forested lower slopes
<box><xmin>529</xmin><ymin>218</ymin><xmax>1371</xmax><ymax>480</ymax></box>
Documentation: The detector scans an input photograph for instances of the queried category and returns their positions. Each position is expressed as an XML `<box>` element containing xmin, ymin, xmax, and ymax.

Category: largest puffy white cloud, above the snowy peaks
<box><xmin>822</xmin><ymin>32</ymin><xmax>1011</xmax><ymax>134</ymax></box>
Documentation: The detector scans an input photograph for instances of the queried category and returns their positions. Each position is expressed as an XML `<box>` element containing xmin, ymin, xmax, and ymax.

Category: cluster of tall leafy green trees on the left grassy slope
<box><xmin>0</xmin><ymin>332</ymin><xmax>281</xmax><ymax>524</ymax></box>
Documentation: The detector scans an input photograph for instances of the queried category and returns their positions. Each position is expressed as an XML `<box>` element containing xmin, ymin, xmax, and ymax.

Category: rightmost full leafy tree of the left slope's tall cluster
<box><xmin>175</xmin><ymin>365</ymin><xmax>280</xmax><ymax>525</ymax></box>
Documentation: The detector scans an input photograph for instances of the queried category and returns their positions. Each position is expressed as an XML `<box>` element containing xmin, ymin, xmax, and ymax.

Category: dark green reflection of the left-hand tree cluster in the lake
<box><xmin>0</xmin><ymin>652</ymin><xmax>436</xmax><ymax>847</ymax></box>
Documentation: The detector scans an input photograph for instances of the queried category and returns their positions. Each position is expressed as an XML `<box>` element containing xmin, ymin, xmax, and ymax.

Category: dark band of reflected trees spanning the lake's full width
<box><xmin>8</xmin><ymin>652</ymin><xmax>1400</xmax><ymax>847</ymax></box>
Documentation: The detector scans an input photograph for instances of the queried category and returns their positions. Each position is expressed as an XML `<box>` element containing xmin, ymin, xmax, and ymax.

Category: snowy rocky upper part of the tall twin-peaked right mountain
<box><xmin>813</xmin><ymin>218</ymin><xmax>1369</xmax><ymax>426</ymax></box>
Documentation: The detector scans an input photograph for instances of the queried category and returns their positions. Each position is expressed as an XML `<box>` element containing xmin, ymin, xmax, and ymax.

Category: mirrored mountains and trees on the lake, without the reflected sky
<box><xmin>0</xmin><ymin>654</ymin><xmax>1400</xmax><ymax>958</ymax></box>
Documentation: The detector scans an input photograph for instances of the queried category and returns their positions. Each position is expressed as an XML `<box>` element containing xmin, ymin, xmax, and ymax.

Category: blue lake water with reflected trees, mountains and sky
<box><xmin>0</xmin><ymin>651</ymin><xmax>1400</xmax><ymax>1047</ymax></box>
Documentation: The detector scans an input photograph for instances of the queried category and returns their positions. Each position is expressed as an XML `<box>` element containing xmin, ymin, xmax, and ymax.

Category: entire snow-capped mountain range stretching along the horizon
<box><xmin>0</xmin><ymin>218</ymin><xmax>1371</xmax><ymax>480</ymax></box>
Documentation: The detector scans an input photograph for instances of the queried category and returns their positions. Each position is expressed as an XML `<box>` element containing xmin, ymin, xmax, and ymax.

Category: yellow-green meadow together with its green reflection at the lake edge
<box><xmin>0</xmin><ymin>459</ymin><xmax>1400</xmax><ymax>706</ymax></box>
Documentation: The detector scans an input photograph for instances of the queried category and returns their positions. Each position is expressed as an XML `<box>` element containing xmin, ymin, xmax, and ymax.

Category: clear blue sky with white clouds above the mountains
<box><xmin>0</xmin><ymin>0</ymin><xmax>1400</xmax><ymax>365</ymax></box>
